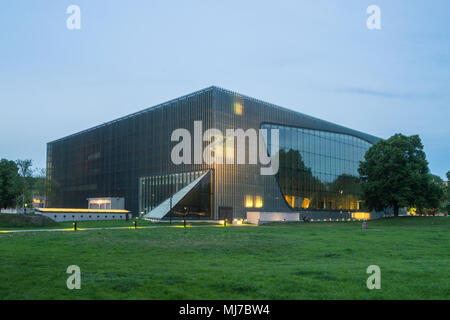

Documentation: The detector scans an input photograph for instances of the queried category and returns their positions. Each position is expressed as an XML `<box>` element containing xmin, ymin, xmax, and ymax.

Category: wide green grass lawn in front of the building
<box><xmin>0</xmin><ymin>217</ymin><xmax>450</xmax><ymax>299</ymax></box>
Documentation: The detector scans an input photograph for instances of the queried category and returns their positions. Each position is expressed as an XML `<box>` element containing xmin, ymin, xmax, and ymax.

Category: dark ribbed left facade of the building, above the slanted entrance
<box><xmin>47</xmin><ymin>90</ymin><xmax>212</xmax><ymax>214</ymax></box>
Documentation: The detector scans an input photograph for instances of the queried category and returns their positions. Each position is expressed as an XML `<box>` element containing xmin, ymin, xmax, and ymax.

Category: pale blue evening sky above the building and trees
<box><xmin>0</xmin><ymin>0</ymin><xmax>450</xmax><ymax>177</ymax></box>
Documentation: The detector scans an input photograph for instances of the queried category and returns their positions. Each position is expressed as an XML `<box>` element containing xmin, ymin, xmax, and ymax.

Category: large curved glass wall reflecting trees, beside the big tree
<box><xmin>262</xmin><ymin>124</ymin><xmax>371</xmax><ymax>210</ymax></box>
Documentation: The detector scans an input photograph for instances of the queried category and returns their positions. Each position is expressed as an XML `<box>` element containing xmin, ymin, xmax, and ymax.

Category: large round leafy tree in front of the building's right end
<box><xmin>358</xmin><ymin>134</ymin><xmax>434</xmax><ymax>217</ymax></box>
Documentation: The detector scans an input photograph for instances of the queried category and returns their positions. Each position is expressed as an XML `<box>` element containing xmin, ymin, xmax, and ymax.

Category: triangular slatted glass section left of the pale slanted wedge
<box><xmin>139</xmin><ymin>170</ymin><xmax>211</xmax><ymax>215</ymax></box>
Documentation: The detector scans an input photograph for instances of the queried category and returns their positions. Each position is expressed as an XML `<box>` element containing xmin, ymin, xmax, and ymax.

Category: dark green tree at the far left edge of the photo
<box><xmin>0</xmin><ymin>159</ymin><xmax>21</xmax><ymax>209</ymax></box>
